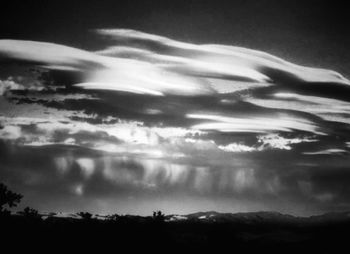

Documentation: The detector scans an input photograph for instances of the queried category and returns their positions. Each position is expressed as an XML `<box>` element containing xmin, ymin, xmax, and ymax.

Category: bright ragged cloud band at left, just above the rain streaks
<box><xmin>0</xmin><ymin>117</ymin><xmax>205</xmax><ymax>157</ymax></box>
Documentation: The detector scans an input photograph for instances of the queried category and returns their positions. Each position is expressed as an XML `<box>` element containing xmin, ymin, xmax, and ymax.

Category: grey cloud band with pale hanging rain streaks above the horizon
<box><xmin>0</xmin><ymin>138</ymin><xmax>348</xmax><ymax>215</ymax></box>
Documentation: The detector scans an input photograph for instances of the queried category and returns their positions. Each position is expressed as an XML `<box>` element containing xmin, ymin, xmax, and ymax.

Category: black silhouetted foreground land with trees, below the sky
<box><xmin>0</xmin><ymin>209</ymin><xmax>350</xmax><ymax>253</ymax></box>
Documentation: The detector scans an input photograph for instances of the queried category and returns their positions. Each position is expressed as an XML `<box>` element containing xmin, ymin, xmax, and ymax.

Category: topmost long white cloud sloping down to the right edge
<box><xmin>97</xmin><ymin>29</ymin><xmax>349</xmax><ymax>85</ymax></box>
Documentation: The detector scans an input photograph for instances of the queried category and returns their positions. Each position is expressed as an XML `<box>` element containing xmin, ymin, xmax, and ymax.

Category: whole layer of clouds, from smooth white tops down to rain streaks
<box><xmin>0</xmin><ymin>29</ymin><xmax>350</xmax><ymax>214</ymax></box>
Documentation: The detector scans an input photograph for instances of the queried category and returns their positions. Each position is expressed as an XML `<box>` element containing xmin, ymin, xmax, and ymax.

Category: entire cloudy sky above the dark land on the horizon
<box><xmin>0</xmin><ymin>0</ymin><xmax>350</xmax><ymax>216</ymax></box>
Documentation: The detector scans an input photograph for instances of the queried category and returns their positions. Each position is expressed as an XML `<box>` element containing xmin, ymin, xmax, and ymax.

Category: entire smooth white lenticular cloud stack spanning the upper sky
<box><xmin>0</xmin><ymin>29</ymin><xmax>350</xmax><ymax>96</ymax></box>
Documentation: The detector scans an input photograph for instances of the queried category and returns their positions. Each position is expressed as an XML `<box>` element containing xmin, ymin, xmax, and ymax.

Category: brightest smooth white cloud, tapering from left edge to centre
<box><xmin>0</xmin><ymin>40</ymin><xmax>211</xmax><ymax>95</ymax></box>
